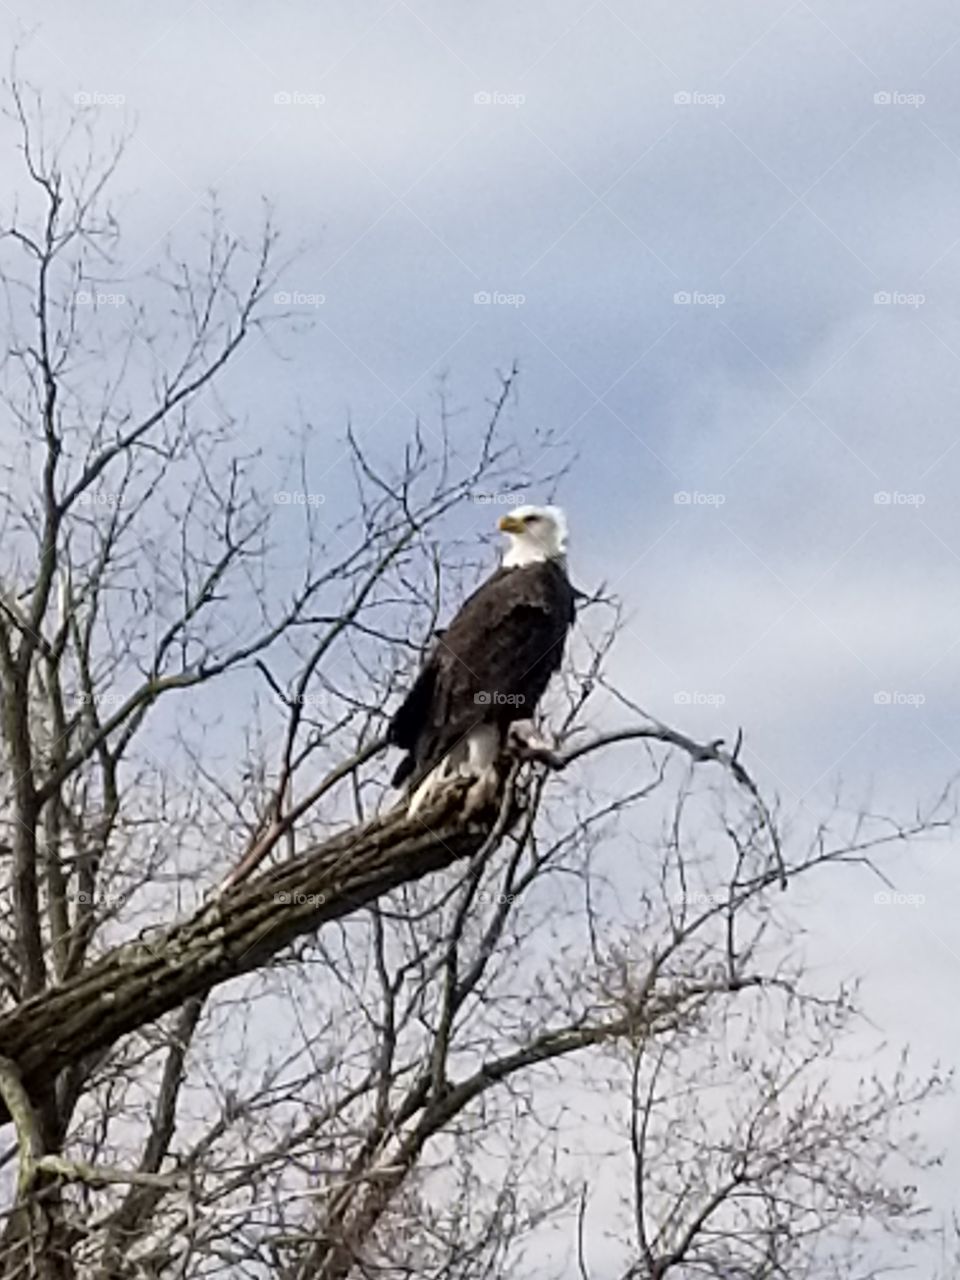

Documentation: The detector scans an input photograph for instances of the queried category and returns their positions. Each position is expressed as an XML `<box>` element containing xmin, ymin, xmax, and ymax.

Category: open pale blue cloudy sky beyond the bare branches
<box><xmin>7</xmin><ymin>0</ymin><xmax>960</xmax><ymax>1269</ymax></box>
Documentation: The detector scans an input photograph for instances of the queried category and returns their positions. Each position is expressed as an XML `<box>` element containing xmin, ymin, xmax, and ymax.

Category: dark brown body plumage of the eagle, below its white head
<box><xmin>389</xmin><ymin>559</ymin><xmax>575</xmax><ymax>786</ymax></box>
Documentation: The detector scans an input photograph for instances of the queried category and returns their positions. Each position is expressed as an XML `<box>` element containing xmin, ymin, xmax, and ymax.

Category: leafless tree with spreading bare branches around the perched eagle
<box><xmin>0</xmin><ymin>79</ymin><xmax>951</xmax><ymax>1280</ymax></box>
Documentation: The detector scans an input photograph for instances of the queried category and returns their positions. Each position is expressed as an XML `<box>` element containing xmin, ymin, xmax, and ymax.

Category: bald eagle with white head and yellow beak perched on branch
<box><xmin>388</xmin><ymin>506</ymin><xmax>577</xmax><ymax>813</ymax></box>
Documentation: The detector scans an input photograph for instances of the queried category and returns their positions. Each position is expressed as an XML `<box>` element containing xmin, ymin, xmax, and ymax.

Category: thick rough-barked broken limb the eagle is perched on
<box><xmin>0</xmin><ymin>788</ymin><xmax>495</xmax><ymax>1120</ymax></box>
